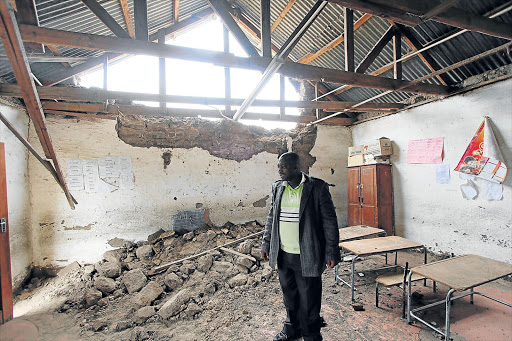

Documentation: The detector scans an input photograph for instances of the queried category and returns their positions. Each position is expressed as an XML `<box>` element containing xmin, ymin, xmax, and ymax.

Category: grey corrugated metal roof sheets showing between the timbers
<box><xmin>0</xmin><ymin>0</ymin><xmax>512</xmax><ymax>113</ymax></box>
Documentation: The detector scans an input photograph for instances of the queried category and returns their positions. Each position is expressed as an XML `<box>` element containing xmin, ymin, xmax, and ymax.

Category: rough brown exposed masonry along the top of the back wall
<box><xmin>117</xmin><ymin>116</ymin><xmax>316</xmax><ymax>167</ymax></box>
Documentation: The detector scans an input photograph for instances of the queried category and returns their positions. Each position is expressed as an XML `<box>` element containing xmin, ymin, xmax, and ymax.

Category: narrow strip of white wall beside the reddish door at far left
<box><xmin>0</xmin><ymin>104</ymin><xmax>32</xmax><ymax>289</ymax></box>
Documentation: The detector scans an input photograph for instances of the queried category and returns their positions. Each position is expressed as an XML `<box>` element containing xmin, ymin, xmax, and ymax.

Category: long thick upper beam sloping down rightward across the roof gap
<box><xmin>20</xmin><ymin>25</ymin><xmax>448</xmax><ymax>95</ymax></box>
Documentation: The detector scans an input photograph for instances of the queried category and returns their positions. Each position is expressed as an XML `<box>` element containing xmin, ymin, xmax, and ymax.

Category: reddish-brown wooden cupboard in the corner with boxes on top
<box><xmin>347</xmin><ymin>164</ymin><xmax>395</xmax><ymax>236</ymax></box>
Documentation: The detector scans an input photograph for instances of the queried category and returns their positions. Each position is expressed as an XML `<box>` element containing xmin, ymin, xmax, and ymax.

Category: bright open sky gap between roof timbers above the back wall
<box><xmin>80</xmin><ymin>19</ymin><xmax>300</xmax><ymax>130</ymax></box>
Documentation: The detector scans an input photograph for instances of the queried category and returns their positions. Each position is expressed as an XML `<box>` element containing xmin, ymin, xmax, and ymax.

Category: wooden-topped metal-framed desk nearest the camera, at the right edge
<box><xmin>407</xmin><ymin>255</ymin><xmax>512</xmax><ymax>340</ymax></box>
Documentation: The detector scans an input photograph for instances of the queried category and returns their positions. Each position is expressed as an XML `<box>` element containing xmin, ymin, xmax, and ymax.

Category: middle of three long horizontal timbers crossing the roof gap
<box><xmin>0</xmin><ymin>83</ymin><xmax>404</xmax><ymax>111</ymax></box>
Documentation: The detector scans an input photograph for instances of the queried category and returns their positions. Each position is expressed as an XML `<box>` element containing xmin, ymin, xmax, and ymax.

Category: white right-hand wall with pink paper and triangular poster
<box><xmin>352</xmin><ymin>80</ymin><xmax>512</xmax><ymax>263</ymax></box>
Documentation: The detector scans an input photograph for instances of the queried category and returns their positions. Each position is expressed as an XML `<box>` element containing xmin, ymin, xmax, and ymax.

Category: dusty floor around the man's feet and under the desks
<box><xmin>0</xmin><ymin>248</ymin><xmax>512</xmax><ymax>341</ymax></box>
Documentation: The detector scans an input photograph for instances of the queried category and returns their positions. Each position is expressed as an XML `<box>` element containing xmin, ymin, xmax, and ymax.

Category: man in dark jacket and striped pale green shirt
<box><xmin>261</xmin><ymin>152</ymin><xmax>340</xmax><ymax>341</ymax></box>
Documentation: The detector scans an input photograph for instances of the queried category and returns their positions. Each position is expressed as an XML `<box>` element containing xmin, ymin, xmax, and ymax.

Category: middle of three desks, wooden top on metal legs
<box><xmin>340</xmin><ymin>236</ymin><xmax>427</xmax><ymax>303</ymax></box>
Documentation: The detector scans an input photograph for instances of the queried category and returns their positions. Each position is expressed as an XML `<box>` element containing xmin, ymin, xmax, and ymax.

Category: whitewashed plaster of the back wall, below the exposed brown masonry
<box><xmin>30</xmin><ymin>117</ymin><xmax>350</xmax><ymax>265</ymax></box>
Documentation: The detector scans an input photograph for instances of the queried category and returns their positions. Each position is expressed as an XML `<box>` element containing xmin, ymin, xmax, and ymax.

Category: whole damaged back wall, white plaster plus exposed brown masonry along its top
<box><xmin>30</xmin><ymin>116</ymin><xmax>350</xmax><ymax>265</ymax></box>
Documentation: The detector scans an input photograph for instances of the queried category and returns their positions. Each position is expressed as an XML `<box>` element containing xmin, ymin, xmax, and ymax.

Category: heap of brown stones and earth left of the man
<box><xmin>17</xmin><ymin>222</ymin><xmax>276</xmax><ymax>339</ymax></box>
